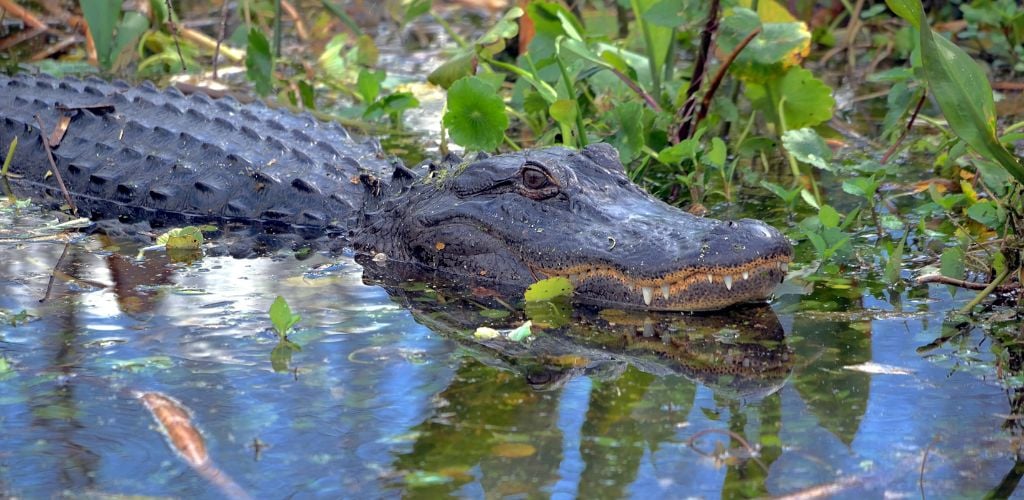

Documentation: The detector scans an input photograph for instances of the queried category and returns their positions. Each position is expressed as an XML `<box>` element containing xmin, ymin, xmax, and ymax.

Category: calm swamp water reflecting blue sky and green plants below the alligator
<box><xmin>0</xmin><ymin>197</ymin><xmax>1024</xmax><ymax>498</ymax></box>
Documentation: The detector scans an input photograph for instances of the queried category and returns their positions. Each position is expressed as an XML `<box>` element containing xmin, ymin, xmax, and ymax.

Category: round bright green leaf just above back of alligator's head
<box><xmin>443</xmin><ymin>77</ymin><xmax>509</xmax><ymax>151</ymax></box>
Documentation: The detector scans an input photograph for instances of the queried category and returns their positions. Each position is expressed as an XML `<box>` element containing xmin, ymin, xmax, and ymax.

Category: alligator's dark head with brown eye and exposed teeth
<box><xmin>351</xmin><ymin>144</ymin><xmax>793</xmax><ymax>310</ymax></box>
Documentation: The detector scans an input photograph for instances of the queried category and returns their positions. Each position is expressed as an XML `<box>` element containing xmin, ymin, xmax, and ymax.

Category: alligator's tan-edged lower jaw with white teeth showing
<box><xmin>535</xmin><ymin>255</ymin><xmax>792</xmax><ymax>310</ymax></box>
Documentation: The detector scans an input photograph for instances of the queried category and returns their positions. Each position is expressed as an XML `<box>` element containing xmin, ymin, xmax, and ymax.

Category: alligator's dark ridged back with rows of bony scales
<box><xmin>0</xmin><ymin>76</ymin><xmax>391</xmax><ymax>231</ymax></box>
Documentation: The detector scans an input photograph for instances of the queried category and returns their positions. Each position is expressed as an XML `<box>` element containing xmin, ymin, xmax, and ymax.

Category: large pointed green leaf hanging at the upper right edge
<box><xmin>921</xmin><ymin>22</ymin><xmax>1024</xmax><ymax>183</ymax></box>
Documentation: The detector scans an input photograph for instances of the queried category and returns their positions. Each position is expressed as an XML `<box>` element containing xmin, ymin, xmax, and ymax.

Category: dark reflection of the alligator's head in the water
<box><xmin>362</xmin><ymin>258</ymin><xmax>792</xmax><ymax>398</ymax></box>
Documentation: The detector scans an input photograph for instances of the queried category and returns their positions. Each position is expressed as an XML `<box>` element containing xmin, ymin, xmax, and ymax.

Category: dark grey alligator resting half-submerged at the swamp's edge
<box><xmin>0</xmin><ymin>75</ymin><xmax>793</xmax><ymax>310</ymax></box>
